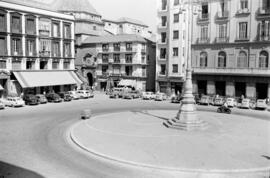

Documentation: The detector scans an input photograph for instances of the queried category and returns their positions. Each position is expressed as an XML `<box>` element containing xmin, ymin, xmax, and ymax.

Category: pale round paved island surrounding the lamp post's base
<box><xmin>70</xmin><ymin>110</ymin><xmax>270</xmax><ymax>178</ymax></box>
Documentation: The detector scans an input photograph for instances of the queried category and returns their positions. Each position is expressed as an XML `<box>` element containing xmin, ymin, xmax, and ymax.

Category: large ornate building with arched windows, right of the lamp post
<box><xmin>192</xmin><ymin>0</ymin><xmax>270</xmax><ymax>99</ymax></box>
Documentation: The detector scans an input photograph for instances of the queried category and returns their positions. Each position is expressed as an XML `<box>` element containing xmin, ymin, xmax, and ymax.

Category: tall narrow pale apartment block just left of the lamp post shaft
<box><xmin>156</xmin><ymin>0</ymin><xmax>189</xmax><ymax>94</ymax></box>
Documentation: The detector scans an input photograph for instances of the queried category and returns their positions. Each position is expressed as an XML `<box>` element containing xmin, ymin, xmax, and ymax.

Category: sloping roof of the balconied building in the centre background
<box><xmin>82</xmin><ymin>34</ymin><xmax>146</xmax><ymax>44</ymax></box>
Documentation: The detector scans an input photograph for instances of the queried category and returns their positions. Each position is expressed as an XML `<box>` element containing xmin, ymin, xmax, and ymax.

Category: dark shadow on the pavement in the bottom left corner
<box><xmin>0</xmin><ymin>161</ymin><xmax>45</xmax><ymax>178</ymax></box>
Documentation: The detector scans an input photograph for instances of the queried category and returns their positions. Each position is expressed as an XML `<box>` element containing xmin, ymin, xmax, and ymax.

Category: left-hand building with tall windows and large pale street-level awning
<box><xmin>0</xmin><ymin>0</ymin><xmax>81</xmax><ymax>97</ymax></box>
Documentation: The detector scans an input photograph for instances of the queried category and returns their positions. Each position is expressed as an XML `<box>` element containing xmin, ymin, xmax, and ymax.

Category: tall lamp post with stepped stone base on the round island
<box><xmin>164</xmin><ymin>0</ymin><xmax>207</xmax><ymax>131</ymax></box>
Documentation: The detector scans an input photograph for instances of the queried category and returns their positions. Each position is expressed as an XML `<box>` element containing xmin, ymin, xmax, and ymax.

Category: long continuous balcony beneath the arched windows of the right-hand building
<box><xmin>193</xmin><ymin>67</ymin><xmax>270</xmax><ymax>77</ymax></box>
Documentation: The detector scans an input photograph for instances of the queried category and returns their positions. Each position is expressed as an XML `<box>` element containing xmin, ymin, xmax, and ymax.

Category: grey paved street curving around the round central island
<box><xmin>0</xmin><ymin>94</ymin><xmax>270</xmax><ymax>178</ymax></box>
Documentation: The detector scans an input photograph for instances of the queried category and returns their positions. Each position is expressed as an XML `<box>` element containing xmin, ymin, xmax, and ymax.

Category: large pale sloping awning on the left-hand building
<box><xmin>13</xmin><ymin>71</ymin><xmax>82</xmax><ymax>88</ymax></box>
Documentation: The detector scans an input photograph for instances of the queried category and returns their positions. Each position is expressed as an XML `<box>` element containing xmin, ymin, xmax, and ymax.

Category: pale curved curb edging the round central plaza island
<box><xmin>67</xmin><ymin>111</ymin><xmax>270</xmax><ymax>177</ymax></box>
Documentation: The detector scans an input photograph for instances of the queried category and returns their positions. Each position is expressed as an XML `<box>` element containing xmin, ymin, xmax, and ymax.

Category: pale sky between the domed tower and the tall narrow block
<box><xmin>89</xmin><ymin>0</ymin><xmax>157</xmax><ymax>32</ymax></box>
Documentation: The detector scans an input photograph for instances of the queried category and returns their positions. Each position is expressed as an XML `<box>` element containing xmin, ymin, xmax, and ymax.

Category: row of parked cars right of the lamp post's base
<box><xmin>197</xmin><ymin>95</ymin><xmax>268</xmax><ymax>109</ymax></box>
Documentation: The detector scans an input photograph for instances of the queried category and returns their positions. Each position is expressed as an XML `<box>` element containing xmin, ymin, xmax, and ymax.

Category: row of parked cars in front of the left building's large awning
<box><xmin>0</xmin><ymin>90</ymin><xmax>94</xmax><ymax>109</ymax></box>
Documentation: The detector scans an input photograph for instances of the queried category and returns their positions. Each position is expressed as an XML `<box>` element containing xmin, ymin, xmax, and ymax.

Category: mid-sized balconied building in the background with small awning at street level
<box><xmin>78</xmin><ymin>34</ymin><xmax>156</xmax><ymax>91</ymax></box>
